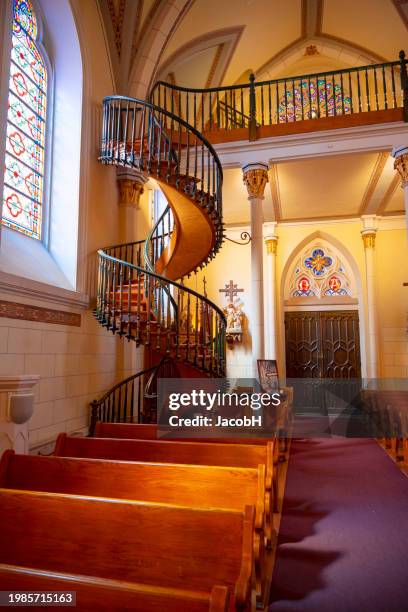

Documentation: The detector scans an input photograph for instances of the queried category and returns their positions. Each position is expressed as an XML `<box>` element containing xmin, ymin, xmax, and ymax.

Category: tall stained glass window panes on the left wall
<box><xmin>1</xmin><ymin>0</ymin><xmax>53</xmax><ymax>247</ymax></box>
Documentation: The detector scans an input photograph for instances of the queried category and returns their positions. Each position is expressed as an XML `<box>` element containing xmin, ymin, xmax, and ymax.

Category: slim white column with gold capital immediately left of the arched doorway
<box><xmin>264</xmin><ymin>222</ymin><xmax>278</xmax><ymax>359</ymax></box>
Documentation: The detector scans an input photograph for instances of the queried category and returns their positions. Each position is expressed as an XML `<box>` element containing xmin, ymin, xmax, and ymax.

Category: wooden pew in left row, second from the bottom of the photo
<box><xmin>0</xmin><ymin>489</ymin><xmax>255</xmax><ymax>610</ymax></box>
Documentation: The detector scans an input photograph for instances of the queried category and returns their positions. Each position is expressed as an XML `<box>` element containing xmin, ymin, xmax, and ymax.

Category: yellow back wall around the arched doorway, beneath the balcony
<box><xmin>190</xmin><ymin>219</ymin><xmax>408</xmax><ymax>377</ymax></box>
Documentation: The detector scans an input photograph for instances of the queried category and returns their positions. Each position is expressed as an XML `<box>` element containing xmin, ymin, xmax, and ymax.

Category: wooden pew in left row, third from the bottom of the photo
<box><xmin>0</xmin><ymin>450</ymin><xmax>275</xmax><ymax>592</ymax></box>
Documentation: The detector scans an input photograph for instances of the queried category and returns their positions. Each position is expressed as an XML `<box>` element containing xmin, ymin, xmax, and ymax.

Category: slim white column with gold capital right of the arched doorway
<box><xmin>361</xmin><ymin>215</ymin><xmax>378</xmax><ymax>378</ymax></box>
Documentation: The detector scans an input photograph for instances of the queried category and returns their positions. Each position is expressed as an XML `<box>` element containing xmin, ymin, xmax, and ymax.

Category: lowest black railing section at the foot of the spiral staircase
<box><xmin>89</xmin><ymin>357</ymin><xmax>177</xmax><ymax>436</ymax></box>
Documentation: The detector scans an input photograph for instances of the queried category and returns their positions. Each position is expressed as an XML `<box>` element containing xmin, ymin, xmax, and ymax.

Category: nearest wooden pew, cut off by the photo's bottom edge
<box><xmin>0</xmin><ymin>563</ymin><xmax>228</xmax><ymax>612</ymax></box>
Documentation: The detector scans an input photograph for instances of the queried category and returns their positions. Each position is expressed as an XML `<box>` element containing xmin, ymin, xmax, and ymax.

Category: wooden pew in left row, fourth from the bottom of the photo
<box><xmin>54</xmin><ymin>433</ymin><xmax>273</xmax><ymax>491</ymax></box>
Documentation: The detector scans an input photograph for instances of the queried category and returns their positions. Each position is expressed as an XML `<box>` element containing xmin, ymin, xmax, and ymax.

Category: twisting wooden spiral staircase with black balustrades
<box><xmin>93</xmin><ymin>96</ymin><xmax>226</xmax><ymax>428</ymax></box>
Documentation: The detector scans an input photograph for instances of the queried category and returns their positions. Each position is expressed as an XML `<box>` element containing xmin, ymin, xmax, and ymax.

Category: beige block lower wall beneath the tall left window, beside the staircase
<box><xmin>0</xmin><ymin>308</ymin><xmax>128</xmax><ymax>447</ymax></box>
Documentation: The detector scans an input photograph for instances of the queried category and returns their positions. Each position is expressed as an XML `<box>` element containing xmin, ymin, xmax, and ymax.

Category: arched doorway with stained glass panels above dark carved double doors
<box><xmin>284</xmin><ymin>237</ymin><xmax>361</xmax><ymax>379</ymax></box>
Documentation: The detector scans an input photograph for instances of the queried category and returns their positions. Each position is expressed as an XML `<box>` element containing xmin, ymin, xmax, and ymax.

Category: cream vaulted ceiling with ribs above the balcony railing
<box><xmin>158</xmin><ymin>0</ymin><xmax>408</xmax><ymax>87</ymax></box>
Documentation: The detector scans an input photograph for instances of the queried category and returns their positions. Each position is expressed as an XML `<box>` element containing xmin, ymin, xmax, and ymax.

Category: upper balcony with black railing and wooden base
<box><xmin>150</xmin><ymin>51</ymin><xmax>408</xmax><ymax>144</ymax></box>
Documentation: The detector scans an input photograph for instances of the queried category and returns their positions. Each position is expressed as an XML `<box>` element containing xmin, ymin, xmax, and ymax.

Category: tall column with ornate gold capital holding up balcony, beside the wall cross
<box><xmin>242</xmin><ymin>163</ymin><xmax>268</xmax><ymax>378</ymax></box>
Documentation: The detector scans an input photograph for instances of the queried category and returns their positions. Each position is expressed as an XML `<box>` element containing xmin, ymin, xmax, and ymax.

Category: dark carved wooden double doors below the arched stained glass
<box><xmin>285</xmin><ymin>310</ymin><xmax>361</xmax><ymax>379</ymax></box>
